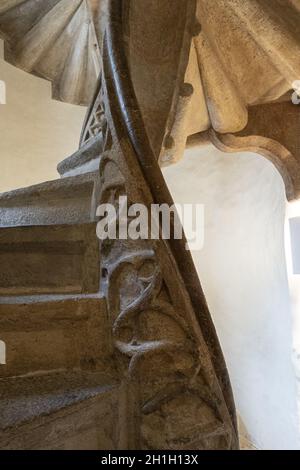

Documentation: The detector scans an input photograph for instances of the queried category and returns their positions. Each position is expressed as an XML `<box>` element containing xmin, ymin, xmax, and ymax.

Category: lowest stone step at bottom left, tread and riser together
<box><xmin>0</xmin><ymin>372</ymin><xmax>118</xmax><ymax>450</ymax></box>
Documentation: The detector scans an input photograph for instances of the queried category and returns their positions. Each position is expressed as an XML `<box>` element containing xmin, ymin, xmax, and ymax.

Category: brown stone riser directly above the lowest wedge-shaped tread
<box><xmin>0</xmin><ymin>297</ymin><xmax>111</xmax><ymax>378</ymax></box>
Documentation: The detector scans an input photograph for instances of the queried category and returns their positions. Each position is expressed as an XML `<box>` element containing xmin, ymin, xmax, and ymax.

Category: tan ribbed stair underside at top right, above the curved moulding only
<box><xmin>195</xmin><ymin>0</ymin><xmax>300</xmax><ymax>133</ymax></box>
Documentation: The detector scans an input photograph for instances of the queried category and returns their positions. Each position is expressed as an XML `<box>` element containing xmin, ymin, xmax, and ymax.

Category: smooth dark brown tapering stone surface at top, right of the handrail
<box><xmin>124</xmin><ymin>0</ymin><xmax>195</xmax><ymax>157</ymax></box>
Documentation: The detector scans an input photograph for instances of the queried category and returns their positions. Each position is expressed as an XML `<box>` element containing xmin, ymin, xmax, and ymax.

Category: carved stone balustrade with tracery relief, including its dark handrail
<box><xmin>91</xmin><ymin>0</ymin><xmax>238</xmax><ymax>449</ymax></box>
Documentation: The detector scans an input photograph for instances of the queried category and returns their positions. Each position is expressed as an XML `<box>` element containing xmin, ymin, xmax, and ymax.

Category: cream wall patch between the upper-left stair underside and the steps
<box><xmin>0</xmin><ymin>41</ymin><xmax>86</xmax><ymax>192</ymax></box>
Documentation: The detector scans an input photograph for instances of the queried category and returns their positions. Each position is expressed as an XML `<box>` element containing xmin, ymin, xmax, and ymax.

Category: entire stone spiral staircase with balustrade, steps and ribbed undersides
<box><xmin>0</xmin><ymin>0</ymin><xmax>300</xmax><ymax>449</ymax></box>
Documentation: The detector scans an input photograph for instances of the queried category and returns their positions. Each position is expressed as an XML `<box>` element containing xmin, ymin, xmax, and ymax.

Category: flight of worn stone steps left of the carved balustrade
<box><xmin>0</xmin><ymin>140</ymin><xmax>118</xmax><ymax>449</ymax></box>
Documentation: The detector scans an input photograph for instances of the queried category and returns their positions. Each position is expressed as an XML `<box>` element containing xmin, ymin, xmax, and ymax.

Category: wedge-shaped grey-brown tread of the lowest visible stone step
<box><xmin>0</xmin><ymin>371</ymin><xmax>116</xmax><ymax>432</ymax></box>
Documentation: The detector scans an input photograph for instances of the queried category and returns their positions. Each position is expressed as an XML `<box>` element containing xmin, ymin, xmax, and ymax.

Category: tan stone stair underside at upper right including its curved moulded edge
<box><xmin>160</xmin><ymin>0</ymin><xmax>300</xmax><ymax>200</ymax></box>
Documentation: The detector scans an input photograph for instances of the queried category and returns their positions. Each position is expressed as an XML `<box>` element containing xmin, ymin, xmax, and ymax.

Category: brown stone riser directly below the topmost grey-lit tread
<box><xmin>0</xmin><ymin>223</ymin><xmax>100</xmax><ymax>296</ymax></box>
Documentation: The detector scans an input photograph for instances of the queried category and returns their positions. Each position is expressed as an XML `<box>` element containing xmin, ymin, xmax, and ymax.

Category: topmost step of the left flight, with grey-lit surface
<box><xmin>0</xmin><ymin>172</ymin><xmax>98</xmax><ymax>227</ymax></box>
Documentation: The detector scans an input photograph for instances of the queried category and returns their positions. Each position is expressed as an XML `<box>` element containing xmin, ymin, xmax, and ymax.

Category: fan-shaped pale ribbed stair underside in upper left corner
<box><xmin>0</xmin><ymin>0</ymin><xmax>100</xmax><ymax>106</ymax></box>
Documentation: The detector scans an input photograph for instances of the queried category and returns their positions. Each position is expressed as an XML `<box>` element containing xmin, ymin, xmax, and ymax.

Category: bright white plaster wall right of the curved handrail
<box><xmin>164</xmin><ymin>147</ymin><xmax>300</xmax><ymax>449</ymax></box>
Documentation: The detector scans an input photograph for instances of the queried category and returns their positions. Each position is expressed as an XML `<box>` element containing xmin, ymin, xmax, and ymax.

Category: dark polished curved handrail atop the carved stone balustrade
<box><xmin>105</xmin><ymin>0</ymin><xmax>238</xmax><ymax>422</ymax></box>
